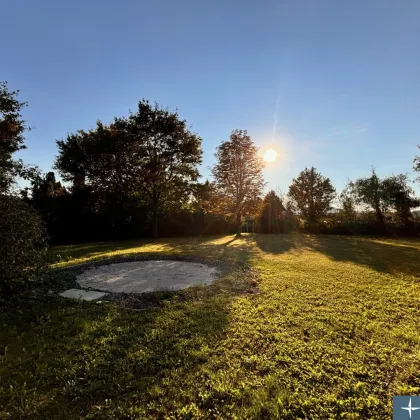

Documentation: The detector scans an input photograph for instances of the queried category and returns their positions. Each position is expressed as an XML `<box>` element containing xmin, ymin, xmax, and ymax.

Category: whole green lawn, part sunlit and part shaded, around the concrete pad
<box><xmin>0</xmin><ymin>235</ymin><xmax>420</xmax><ymax>420</ymax></box>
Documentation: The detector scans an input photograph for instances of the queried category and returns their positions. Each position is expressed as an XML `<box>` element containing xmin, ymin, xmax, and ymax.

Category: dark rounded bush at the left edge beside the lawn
<box><xmin>0</xmin><ymin>196</ymin><xmax>46</xmax><ymax>291</ymax></box>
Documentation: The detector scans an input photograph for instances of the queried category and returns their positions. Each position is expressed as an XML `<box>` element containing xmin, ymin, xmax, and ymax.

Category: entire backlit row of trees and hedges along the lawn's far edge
<box><xmin>0</xmin><ymin>82</ymin><xmax>420</xmax><ymax>288</ymax></box>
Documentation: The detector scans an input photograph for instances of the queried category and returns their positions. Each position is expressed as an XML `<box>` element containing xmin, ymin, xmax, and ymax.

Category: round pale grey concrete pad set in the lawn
<box><xmin>77</xmin><ymin>260</ymin><xmax>217</xmax><ymax>293</ymax></box>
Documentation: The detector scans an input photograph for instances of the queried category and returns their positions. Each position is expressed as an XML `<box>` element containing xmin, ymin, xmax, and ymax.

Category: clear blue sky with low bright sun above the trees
<box><xmin>0</xmin><ymin>0</ymin><xmax>420</xmax><ymax>193</ymax></box>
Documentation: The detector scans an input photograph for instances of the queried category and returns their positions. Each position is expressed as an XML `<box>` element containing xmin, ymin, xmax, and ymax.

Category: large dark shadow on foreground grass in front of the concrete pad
<box><xmin>0</xmin><ymin>290</ymin><xmax>232</xmax><ymax>419</ymax></box>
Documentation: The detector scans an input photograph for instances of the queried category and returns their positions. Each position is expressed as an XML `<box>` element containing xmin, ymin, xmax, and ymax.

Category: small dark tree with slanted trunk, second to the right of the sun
<box><xmin>349</xmin><ymin>169</ymin><xmax>388</xmax><ymax>228</ymax></box>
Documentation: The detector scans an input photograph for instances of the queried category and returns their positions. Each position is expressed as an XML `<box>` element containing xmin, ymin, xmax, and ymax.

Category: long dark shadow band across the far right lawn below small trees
<box><xmin>251</xmin><ymin>234</ymin><xmax>420</xmax><ymax>277</ymax></box>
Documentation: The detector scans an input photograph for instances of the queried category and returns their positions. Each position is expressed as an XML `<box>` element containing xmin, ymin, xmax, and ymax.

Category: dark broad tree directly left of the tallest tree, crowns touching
<box><xmin>55</xmin><ymin>119</ymin><xmax>140</xmax><ymax>236</ymax></box>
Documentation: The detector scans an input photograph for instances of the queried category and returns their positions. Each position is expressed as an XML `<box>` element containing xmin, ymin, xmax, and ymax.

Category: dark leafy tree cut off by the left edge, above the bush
<box><xmin>0</xmin><ymin>82</ymin><xmax>36</xmax><ymax>194</ymax></box>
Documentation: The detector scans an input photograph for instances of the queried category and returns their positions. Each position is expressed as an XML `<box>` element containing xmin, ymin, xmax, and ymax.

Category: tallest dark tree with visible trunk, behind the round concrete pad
<box><xmin>123</xmin><ymin>100</ymin><xmax>202</xmax><ymax>237</ymax></box>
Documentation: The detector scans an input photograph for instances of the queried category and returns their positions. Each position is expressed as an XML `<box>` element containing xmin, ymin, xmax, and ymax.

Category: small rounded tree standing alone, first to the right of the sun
<box><xmin>288</xmin><ymin>167</ymin><xmax>335</xmax><ymax>227</ymax></box>
